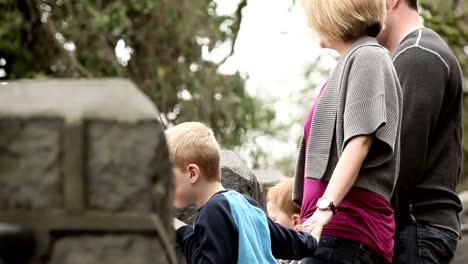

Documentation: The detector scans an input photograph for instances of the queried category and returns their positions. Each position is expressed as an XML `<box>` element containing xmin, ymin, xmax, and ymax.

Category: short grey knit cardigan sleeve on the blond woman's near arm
<box><xmin>342</xmin><ymin>46</ymin><xmax>401</xmax><ymax>168</ymax></box>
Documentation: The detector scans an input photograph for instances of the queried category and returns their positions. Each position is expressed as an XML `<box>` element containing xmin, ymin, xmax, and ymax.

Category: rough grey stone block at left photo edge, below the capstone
<box><xmin>0</xmin><ymin>118</ymin><xmax>63</xmax><ymax>209</ymax></box>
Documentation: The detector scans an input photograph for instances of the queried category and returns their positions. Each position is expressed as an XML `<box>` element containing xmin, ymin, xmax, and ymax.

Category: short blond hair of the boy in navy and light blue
<box><xmin>165</xmin><ymin>122</ymin><xmax>221</xmax><ymax>181</ymax></box>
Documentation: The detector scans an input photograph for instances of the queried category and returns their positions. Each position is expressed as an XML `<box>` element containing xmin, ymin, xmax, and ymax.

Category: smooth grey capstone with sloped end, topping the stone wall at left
<box><xmin>0</xmin><ymin>79</ymin><xmax>158</xmax><ymax>123</ymax></box>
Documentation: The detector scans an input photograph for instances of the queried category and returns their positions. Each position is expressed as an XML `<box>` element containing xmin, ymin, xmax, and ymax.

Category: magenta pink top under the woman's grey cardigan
<box><xmin>301</xmin><ymin>83</ymin><xmax>395</xmax><ymax>263</ymax></box>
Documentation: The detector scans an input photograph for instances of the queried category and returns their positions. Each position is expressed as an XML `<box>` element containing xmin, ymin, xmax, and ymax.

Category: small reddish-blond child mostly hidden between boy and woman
<box><xmin>267</xmin><ymin>178</ymin><xmax>302</xmax><ymax>264</ymax></box>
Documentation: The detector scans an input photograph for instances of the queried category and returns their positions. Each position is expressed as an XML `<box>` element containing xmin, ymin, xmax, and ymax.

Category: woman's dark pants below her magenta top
<box><xmin>301</xmin><ymin>235</ymin><xmax>388</xmax><ymax>264</ymax></box>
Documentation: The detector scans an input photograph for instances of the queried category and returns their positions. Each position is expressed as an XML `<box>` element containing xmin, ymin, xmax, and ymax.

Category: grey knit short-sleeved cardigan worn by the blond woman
<box><xmin>293</xmin><ymin>37</ymin><xmax>402</xmax><ymax>205</ymax></box>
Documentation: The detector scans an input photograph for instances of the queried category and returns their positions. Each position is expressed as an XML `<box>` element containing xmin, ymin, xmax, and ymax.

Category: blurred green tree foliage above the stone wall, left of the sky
<box><xmin>0</xmin><ymin>0</ymin><xmax>274</xmax><ymax>148</ymax></box>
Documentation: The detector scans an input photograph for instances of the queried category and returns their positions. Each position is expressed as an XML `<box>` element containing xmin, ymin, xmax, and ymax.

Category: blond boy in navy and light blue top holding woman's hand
<box><xmin>166</xmin><ymin>122</ymin><xmax>321</xmax><ymax>264</ymax></box>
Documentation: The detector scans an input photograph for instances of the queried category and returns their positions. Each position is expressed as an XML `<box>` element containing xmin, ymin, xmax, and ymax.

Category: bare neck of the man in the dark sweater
<box><xmin>385</xmin><ymin>9</ymin><xmax>424</xmax><ymax>52</ymax></box>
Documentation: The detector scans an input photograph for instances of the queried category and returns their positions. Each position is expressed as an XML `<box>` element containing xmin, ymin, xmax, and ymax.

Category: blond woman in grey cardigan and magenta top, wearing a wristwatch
<box><xmin>293</xmin><ymin>0</ymin><xmax>402</xmax><ymax>264</ymax></box>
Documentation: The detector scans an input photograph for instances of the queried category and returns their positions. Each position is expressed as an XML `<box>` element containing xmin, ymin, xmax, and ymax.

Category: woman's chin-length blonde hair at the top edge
<box><xmin>302</xmin><ymin>0</ymin><xmax>386</xmax><ymax>43</ymax></box>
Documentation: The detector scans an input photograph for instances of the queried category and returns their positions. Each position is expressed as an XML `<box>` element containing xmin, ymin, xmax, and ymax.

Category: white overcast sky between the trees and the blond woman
<box><xmin>211</xmin><ymin>0</ymin><xmax>334</xmax><ymax>165</ymax></box>
